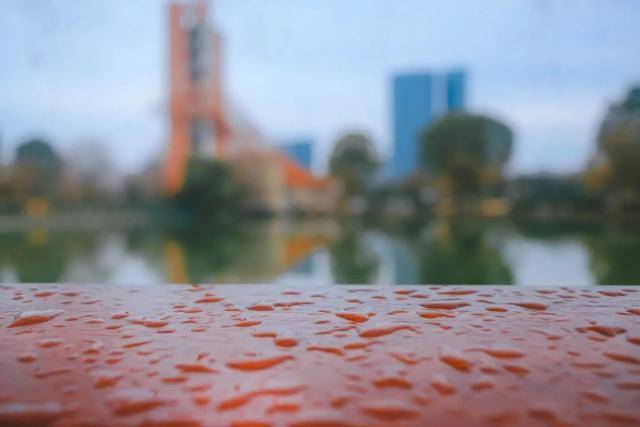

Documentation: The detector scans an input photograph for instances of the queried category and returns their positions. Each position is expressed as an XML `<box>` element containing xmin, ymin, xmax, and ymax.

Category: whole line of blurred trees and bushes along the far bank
<box><xmin>0</xmin><ymin>87</ymin><xmax>640</xmax><ymax>229</ymax></box>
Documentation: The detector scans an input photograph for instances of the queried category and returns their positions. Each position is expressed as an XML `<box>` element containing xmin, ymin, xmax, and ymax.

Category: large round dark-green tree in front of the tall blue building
<box><xmin>420</xmin><ymin>113</ymin><xmax>513</xmax><ymax>201</ymax></box>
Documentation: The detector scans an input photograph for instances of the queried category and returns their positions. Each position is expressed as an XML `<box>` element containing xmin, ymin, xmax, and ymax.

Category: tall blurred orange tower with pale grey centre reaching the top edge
<box><xmin>164</xmin><ymin>0</ymin><xmax>229</xmax><ymax>194</ymax></box>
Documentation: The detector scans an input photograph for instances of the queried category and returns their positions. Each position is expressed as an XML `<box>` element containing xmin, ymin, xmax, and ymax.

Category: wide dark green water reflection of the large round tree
<box><xmin>418</xmin><ymin>220</ymin><xmax>513</xmax><ymax>284</ymax></box>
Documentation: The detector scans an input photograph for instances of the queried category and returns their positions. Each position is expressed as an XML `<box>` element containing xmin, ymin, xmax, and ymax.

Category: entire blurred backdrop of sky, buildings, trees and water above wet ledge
<box><xmin>0</xmin><ymin>0</ymin><xmax>640</xmax><ymax>286</ymax></box>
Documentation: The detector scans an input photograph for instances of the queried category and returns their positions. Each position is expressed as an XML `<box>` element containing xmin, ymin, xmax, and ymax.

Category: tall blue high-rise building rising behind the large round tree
<box><xmin>389</xmin><ymin>70</ymin><xmax>467</xmax><ymax>179</ymax></box>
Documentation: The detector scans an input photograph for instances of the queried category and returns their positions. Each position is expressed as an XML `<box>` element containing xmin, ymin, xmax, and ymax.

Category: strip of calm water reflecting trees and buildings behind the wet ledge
<box><xmin>0</xmin><ymin>220</ymin><xmax>640</xmax><ymax>286</ymax></box>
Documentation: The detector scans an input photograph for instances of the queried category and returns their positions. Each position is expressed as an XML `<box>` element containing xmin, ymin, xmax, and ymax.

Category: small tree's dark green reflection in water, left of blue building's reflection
<box><xmin>329</xmin><ymin>224</ymin><xmax>379</xmax><ymax>283</ymax></box>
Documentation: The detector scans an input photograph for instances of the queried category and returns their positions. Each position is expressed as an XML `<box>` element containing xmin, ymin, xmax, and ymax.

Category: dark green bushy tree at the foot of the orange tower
<box><xmin>174</xmin><ymin>158</ymin><xmax>242</xmax><ymax>223</ymax></box>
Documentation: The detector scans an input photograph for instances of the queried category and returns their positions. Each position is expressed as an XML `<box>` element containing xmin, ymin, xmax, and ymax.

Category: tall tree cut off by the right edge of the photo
<box><xmin>596</xmin><ymin>86</ymin><xmax>640</xmax><ymax>190</ymax></box>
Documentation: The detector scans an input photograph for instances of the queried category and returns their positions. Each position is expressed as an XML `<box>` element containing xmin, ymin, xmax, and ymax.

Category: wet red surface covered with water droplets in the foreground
<box><xmin>0</xmin><ymin>285</ymin><xmax>640</xmax><ymax>427</ymax></box>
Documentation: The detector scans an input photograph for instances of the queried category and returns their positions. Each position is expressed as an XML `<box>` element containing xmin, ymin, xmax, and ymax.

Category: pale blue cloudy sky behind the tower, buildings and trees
<box><xmin>0</xmin><ymin>0</ymin><xmax>640</xmax><ymax>174</ymax></box>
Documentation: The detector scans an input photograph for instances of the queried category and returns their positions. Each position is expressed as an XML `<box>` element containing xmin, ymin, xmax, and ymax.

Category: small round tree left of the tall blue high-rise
<box><xmin>329</xmin><ymin>132</ymin><xmax>379</xmax><ymax>197</ymax></box>
